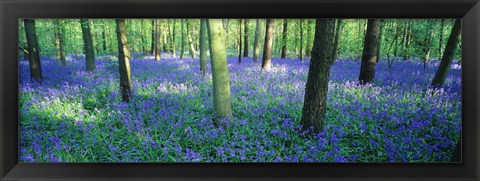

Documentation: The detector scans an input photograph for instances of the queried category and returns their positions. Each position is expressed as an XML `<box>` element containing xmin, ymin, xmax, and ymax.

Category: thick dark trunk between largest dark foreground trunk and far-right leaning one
<box><xmin>358</xmin><ymin>19</ymin><xmax>380</xmax><ymax>84</ymax></box>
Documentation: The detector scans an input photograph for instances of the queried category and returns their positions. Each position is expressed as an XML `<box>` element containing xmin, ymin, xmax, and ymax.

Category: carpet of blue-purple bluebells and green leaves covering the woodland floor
<box><xmin>19</xmin><ymin>55</ymin><xmax>461</xmax><ymax>162</ymax></box>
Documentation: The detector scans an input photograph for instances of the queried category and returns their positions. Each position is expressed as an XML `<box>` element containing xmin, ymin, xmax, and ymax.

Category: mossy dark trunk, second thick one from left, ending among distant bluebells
<box><xmin>80</xmin><ymin>19</ymin><xmax>96</xmax><ymax>72</ymax></box>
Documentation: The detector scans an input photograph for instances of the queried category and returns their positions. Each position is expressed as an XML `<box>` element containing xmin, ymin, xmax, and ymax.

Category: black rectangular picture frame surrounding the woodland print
<box><xmin>0</xmin><ymin>0</ymin><xmax>480</xmax><ymax>181</ymax></box>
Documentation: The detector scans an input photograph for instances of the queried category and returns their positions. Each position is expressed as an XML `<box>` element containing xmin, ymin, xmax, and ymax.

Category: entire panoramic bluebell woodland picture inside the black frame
<box><xmin>17</xmin><ymin>19</ymin><xmax>462</xmax><ymax>162</ymax></box>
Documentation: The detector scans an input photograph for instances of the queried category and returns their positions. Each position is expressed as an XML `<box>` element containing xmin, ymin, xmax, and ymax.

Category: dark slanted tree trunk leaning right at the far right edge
<box><xmin>431</xmin><ymin>19</ymin><xmax>462</xmax><ymax>88</ymax></box>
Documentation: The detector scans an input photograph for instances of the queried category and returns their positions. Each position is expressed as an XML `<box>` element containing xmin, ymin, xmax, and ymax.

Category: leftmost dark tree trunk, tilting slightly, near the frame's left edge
<box><xmin>23</xmin><ymin>19</ymin><xmax>43</xmax><ymax>82</ymax></box>
